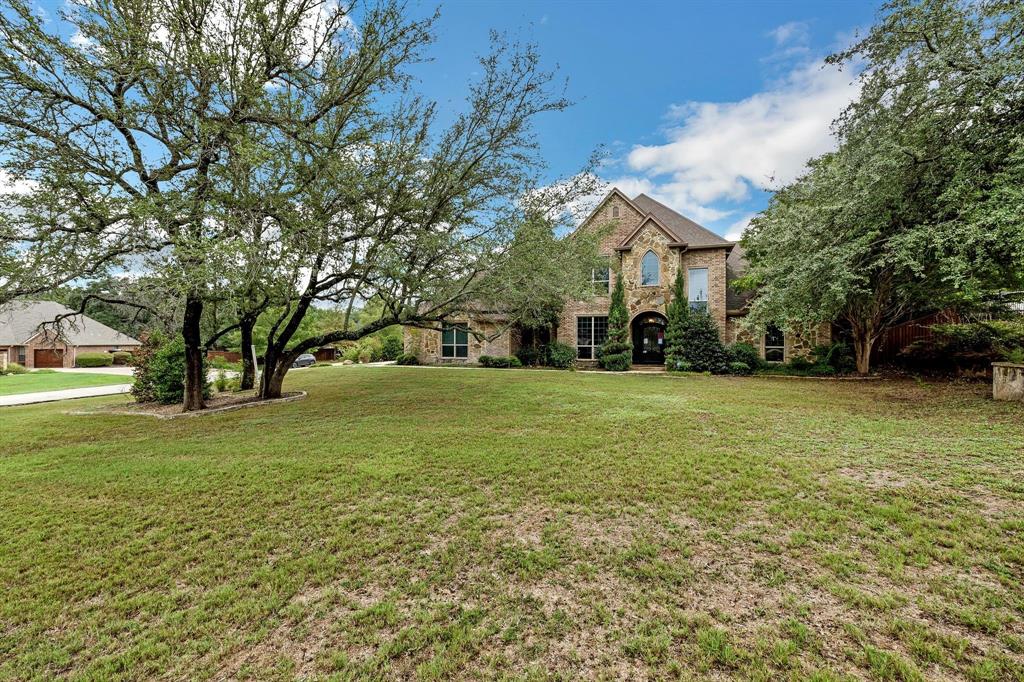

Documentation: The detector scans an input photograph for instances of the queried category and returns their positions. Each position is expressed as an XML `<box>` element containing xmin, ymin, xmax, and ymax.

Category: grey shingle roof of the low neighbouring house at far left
<box><xmin>0</xmin><ymin>301</ymin><xmax>141</xmax><ymax>346</ymax></box>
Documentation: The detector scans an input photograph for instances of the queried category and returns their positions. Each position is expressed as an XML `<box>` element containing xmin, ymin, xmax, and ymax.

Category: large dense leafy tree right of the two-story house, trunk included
<box><xmin>743</xmin><ymin>0</ymin><xmax>1024</xmax><ymax>372</ymax></box>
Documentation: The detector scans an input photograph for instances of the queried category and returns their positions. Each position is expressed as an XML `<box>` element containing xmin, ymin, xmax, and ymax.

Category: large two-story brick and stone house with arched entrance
<box><xmin>406</xmin><ymin>188</ymin><xmax>830</xmax><ymax>365</ymax></box>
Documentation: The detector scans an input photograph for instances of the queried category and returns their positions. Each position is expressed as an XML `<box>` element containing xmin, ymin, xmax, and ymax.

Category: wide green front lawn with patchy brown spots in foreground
<box><xmin>0</xmin><ymin>368</ymin><xmax>1024</xmax><ymax>680</ymax></box>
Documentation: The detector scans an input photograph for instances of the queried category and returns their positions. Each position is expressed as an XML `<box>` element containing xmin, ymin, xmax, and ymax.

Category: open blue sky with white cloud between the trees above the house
<box><xmin>403</xmin><ymin>0</ymin><xmax>877</xmax><ymax>238</ymax></box>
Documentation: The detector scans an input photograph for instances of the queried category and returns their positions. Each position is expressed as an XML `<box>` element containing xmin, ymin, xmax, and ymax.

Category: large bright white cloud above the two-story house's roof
<box><xmin>627</xmin><ymin>63</ymin><xmax>858</xmax><ymax>206</ymax></box>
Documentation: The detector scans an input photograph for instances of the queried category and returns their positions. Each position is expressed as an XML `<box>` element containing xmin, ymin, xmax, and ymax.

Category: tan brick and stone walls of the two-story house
<box><xmin>406</xmin><ymin>190</ymin><xmax>830</xmax><ymax>366</ymax></box>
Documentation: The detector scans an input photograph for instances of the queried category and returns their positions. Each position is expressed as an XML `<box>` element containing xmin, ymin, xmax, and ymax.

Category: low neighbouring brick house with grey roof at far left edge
<box><xmin>0</xmin><ymin>301</ymin><xmax>142</xmax><ymax>369</ymax></box>
